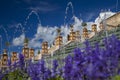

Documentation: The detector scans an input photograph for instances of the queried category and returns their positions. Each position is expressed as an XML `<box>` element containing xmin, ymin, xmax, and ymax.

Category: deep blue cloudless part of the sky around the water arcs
<box><xmin>0</xmin><ymin>0</ymin><xmax>120</xmax><ymax>51</ymax></box>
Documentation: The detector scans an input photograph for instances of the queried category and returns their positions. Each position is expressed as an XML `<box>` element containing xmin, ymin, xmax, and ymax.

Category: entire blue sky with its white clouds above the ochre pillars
<box><xmin>0</xmin><ymin>0</ymin><xmax>120</xmax><ymax>53</ymax></box>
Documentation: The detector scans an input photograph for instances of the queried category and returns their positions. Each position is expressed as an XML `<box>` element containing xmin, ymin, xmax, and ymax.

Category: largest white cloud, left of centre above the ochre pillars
<box><xmin>26</xmin><ymin>25</ymin><xmax>58</xmax><ymax>48</ymax></box>
